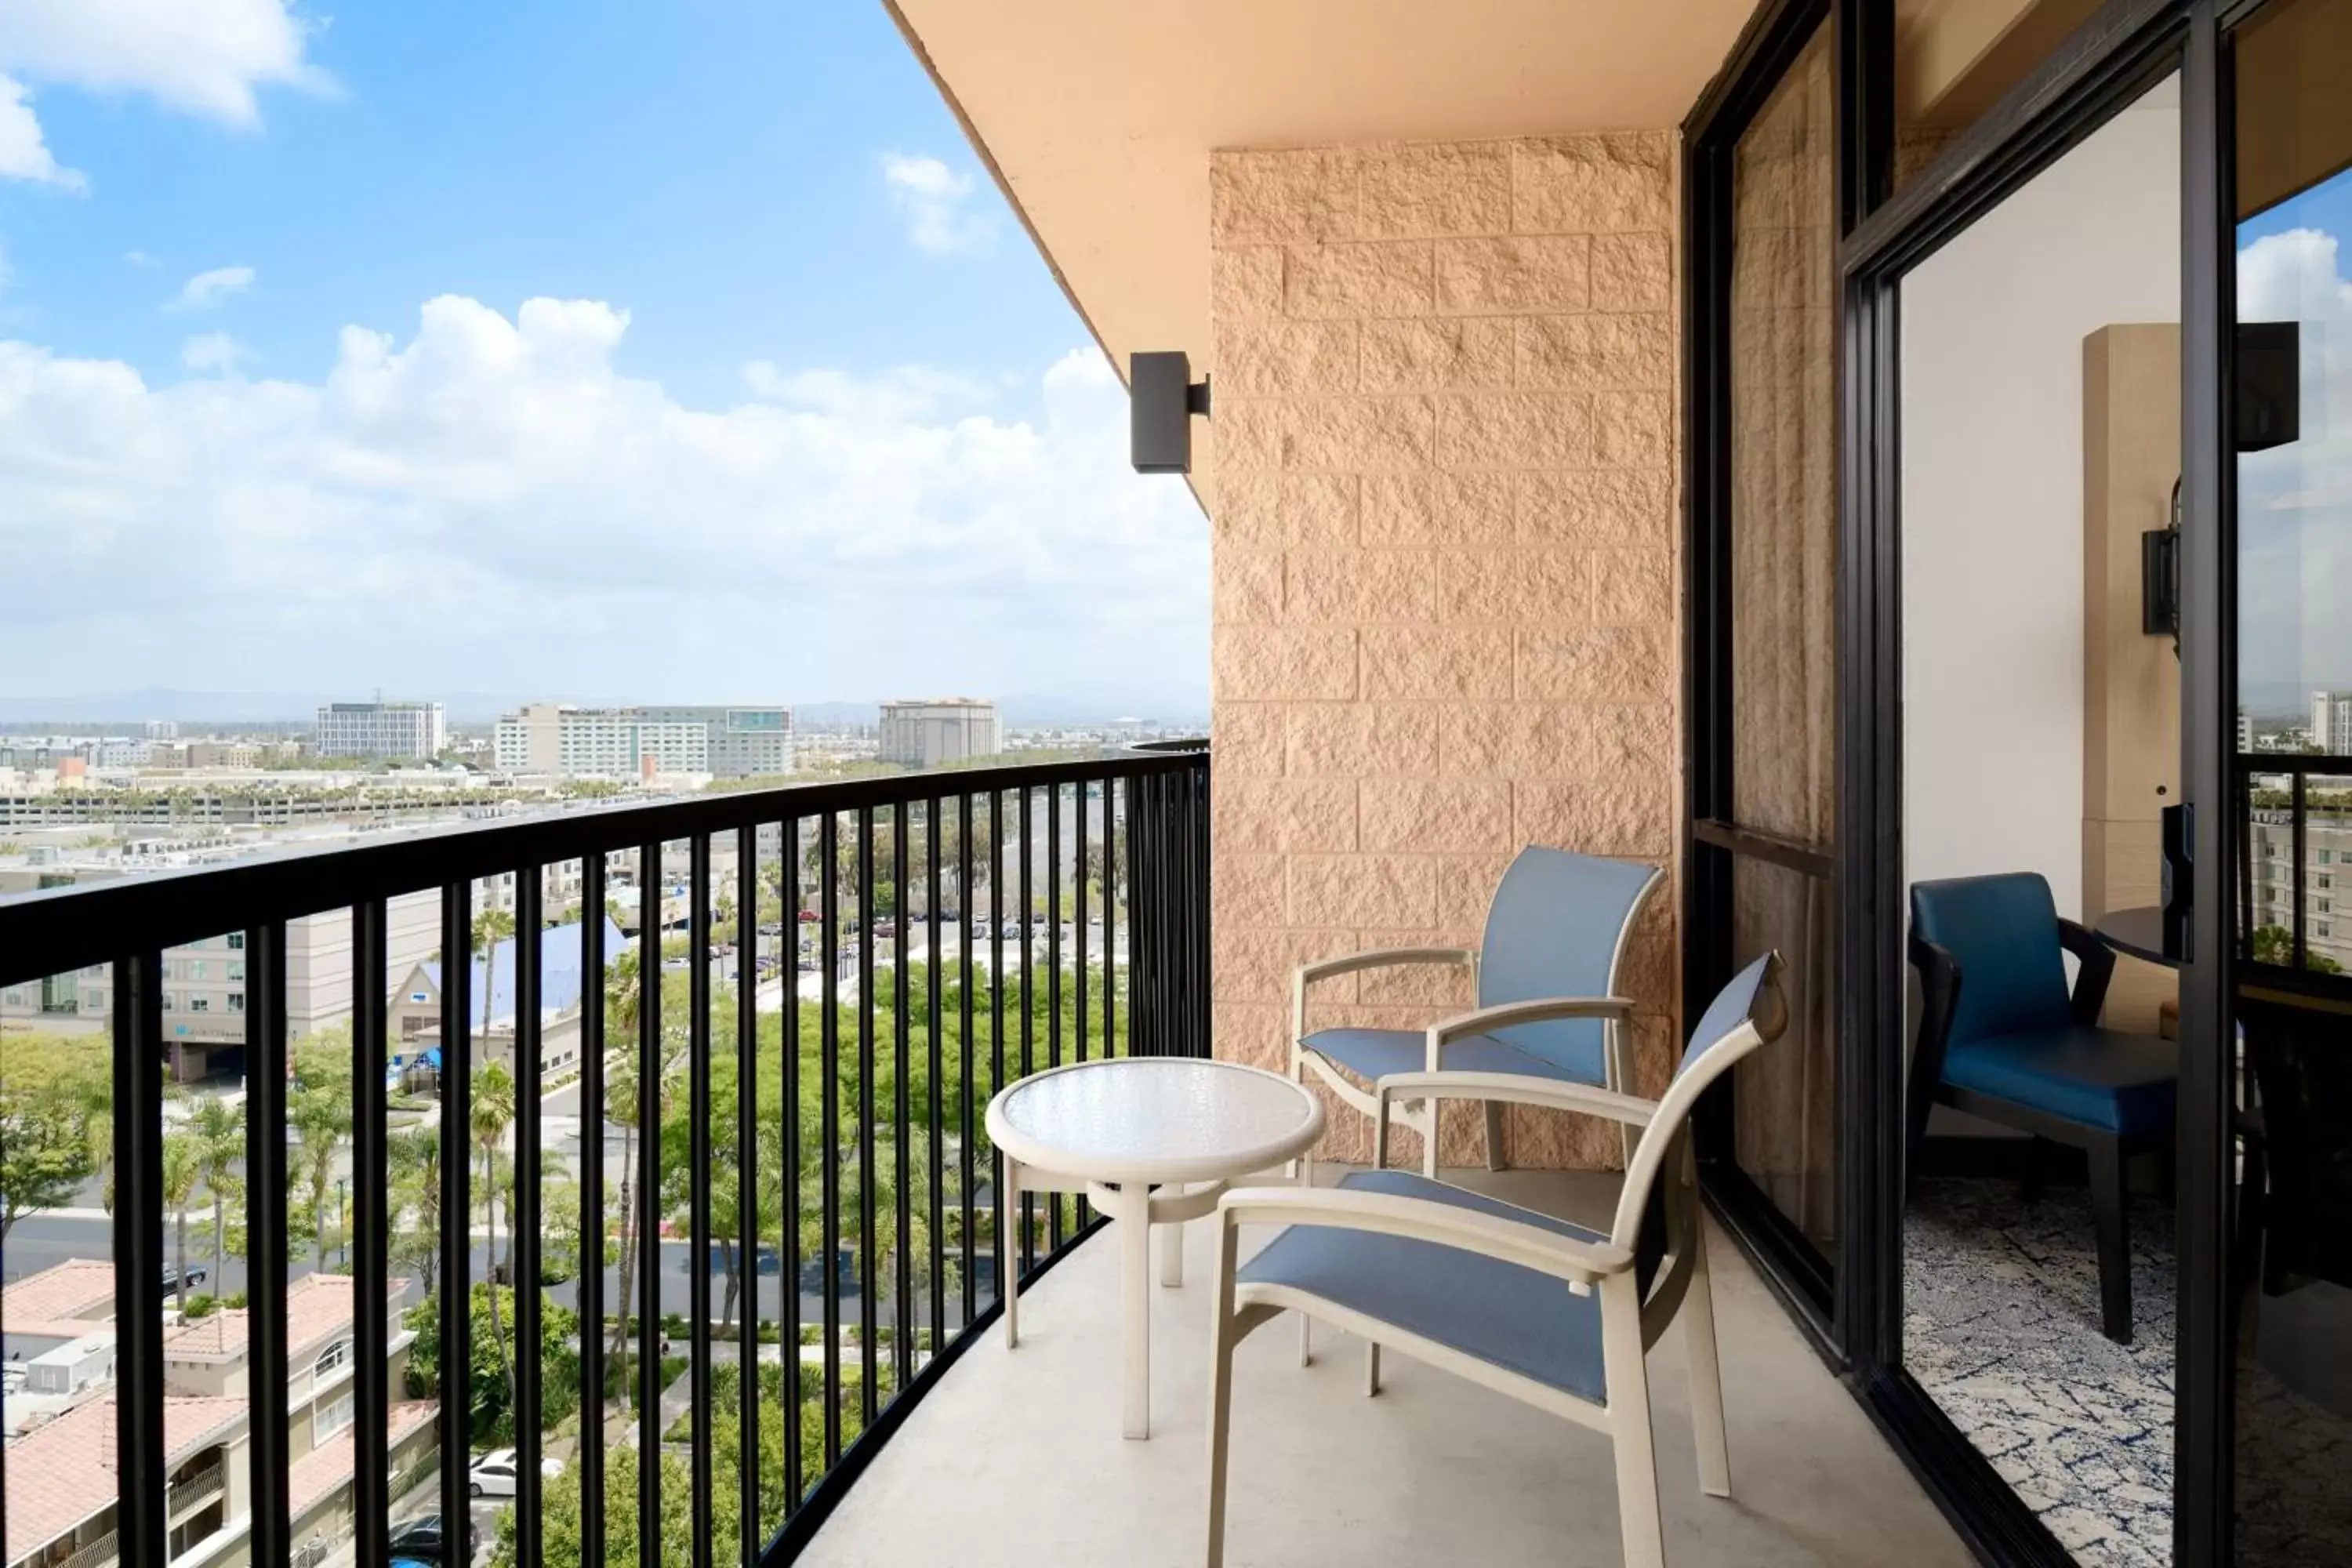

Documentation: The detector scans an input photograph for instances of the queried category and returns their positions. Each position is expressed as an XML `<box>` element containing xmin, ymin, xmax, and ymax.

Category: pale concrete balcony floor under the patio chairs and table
<box><xmin>804</xmin><ymin>1166</ymin><xmax>1973</xmax><ymax>1568</ymax></box>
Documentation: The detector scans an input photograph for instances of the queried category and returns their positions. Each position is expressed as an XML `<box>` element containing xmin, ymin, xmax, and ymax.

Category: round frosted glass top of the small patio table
<box><xmin>988</xmin><ymin>1055</ymin><xmax>1324</xmax><ymax>1180</ymax></box>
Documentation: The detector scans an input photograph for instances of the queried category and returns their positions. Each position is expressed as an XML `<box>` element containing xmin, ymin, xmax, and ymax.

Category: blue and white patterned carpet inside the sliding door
<box><xmin>1903</xmin><ymin>1180</ymin><xmax>2173</xmax><ymax>1568</ymax></box>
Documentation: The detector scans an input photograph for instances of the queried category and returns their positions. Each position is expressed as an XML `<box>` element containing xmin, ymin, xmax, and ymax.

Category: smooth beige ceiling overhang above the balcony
<box><xmin>884</xmin><ymin>0</ymin><xmax>1752</xmax><ymax>496</ymax></box>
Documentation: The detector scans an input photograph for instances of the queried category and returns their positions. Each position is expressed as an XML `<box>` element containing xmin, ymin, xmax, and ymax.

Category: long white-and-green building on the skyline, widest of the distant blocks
<box><xmin>494</xmin><ymin>703</ymin><xmax>793</xmax><ymax>779</ymax></box>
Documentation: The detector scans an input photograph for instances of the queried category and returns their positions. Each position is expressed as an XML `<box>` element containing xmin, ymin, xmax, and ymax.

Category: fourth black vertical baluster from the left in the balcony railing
<box><xmin>437</xmin><ymin>877</ymin><xmax>473</xmax><ymax>1568</ymax></box>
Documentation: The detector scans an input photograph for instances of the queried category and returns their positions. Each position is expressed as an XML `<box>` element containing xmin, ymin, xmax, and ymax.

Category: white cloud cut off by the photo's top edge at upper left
<box><xmin>0</xmin><ymin>0</ymin><xmax>334</xmax><ymax>125</ymax></box>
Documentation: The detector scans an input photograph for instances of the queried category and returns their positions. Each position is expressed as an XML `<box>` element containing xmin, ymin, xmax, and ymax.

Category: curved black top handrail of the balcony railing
<box><xmin>0</xmin><ymin>750</ymin><xmax>1202</xmax><ymax>985</ymax></box>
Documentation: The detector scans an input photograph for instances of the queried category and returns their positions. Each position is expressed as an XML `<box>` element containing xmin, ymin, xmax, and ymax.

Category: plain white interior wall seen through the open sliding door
<box><xmin>1900</xmin><ymin>82</ymin><xmax>2180</xmax><ymax>916</ymax></box>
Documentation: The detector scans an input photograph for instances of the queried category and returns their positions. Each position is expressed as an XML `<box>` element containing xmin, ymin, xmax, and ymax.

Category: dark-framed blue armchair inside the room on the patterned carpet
<box><xmin>1905</xmin><ymin>872</ymin><xmax>2180</xmax><ymax>1345</ymax></box>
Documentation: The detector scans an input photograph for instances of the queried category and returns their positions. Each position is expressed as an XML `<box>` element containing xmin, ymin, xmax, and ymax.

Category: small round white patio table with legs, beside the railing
<box><xmin>988</xmin><ymin>1055</ymin><xmax>1324</xmax><ymax>1439</ymax></box>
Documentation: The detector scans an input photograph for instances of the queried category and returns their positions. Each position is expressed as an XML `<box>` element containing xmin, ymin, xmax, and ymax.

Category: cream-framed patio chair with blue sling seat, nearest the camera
<box><xmin>1207</xmin><ymin>952</ymin><xmax>1788</xmax><ymax>1568</ymax></box>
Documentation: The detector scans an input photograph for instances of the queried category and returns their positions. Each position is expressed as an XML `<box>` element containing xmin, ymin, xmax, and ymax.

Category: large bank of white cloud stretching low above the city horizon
<box><xmin>0</xmin><ymin>296</ymin><xmax>1209</xmax><ymax>713</ymax></box>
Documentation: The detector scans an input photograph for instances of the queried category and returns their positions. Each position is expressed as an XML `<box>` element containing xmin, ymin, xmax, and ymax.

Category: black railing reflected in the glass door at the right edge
<box><xmin>2237</xmin><ymin>753</ymin><xmax>2352</xmax><ymax>987</ymax></box>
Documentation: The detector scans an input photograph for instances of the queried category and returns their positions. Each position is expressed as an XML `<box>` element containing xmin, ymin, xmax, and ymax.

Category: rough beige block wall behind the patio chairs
<box><xmin>1209</xmin><ymin>132</ymin><xmax>1682</xmax><ymax>1163</ymax></box>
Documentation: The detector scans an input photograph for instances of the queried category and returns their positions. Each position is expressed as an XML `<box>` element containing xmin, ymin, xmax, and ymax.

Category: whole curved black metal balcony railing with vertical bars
<box><xmin>0</xmin><ymin>748</ymin><xmax>1209</xmax><ymax>1568</ymax></box>
